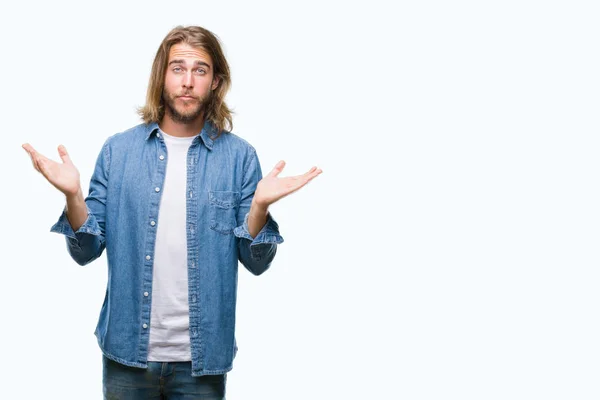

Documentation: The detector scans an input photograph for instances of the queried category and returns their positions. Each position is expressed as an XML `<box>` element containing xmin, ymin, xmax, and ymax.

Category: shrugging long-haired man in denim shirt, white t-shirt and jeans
<box><xmin>23</xmin><ymin>27</ymin><xmax>321</xmax><ymax>400</ymax></box>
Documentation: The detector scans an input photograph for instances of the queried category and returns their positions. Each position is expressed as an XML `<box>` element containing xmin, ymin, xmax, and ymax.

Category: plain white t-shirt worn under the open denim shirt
<box><xmin>148</xmin><ymin>131</ymin><xmax>194</xmax><ymax>361</ymax></box>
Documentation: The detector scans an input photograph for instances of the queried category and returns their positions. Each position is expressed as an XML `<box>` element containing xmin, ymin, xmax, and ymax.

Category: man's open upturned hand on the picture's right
<box><xmin>254</xmin><ymin>160</ymin><xmax>323</xmax><ymax>207</ymax></box>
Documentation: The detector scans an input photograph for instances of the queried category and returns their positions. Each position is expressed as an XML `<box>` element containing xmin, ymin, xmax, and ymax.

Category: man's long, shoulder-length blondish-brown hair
<box><xmin>138</xmin><ymin>26</ymin><xmax>233</xmax><ymax>135</ymax></box>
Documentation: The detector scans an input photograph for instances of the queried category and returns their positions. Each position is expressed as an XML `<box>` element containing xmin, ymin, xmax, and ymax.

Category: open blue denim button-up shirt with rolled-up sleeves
<box><xmin>51</xmin><ymin>122</ymin><xmax>283</xmax><ymax>376</ymax></box>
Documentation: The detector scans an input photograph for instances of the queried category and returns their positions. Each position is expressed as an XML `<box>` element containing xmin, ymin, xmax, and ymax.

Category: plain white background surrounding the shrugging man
<box><xmin>0</xmin><ymin>0</ymin><xmax>600</xmax><ymax>400</ymax></box>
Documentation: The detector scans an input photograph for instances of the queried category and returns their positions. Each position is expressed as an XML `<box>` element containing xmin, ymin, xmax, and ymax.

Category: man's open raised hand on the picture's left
<box><xmin>22</xmin><ymin>143</ymin><xmax>81</xmax><ymax>197</ymax></box>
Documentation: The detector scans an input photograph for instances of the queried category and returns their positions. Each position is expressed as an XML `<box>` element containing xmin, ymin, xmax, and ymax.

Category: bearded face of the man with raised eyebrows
<box><xmin>163</xmin><ymin>43</ymin><xmax>218</xmax><ymax>123</ymax></box>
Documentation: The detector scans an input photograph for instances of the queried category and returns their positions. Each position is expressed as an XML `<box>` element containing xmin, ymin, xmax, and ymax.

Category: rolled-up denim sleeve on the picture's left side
<box><xmin>50</xmin><ymin>140</ymin><xmax>110</xmax><ymax>265</ymax></box>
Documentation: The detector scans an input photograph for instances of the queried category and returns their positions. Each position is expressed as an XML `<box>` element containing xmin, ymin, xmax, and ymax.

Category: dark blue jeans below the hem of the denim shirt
<box><xmin>102</xmin><ymin>356</ymin><xmax>227</xmax><ymax>400</ymax></box>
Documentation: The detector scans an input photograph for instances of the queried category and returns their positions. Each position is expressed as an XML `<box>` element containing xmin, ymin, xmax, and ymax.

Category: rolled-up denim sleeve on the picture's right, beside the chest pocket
<box><xmin>233</xmin><ymin>150</ymin><xmax>283</xmax><ymax>275</ymax></box>
